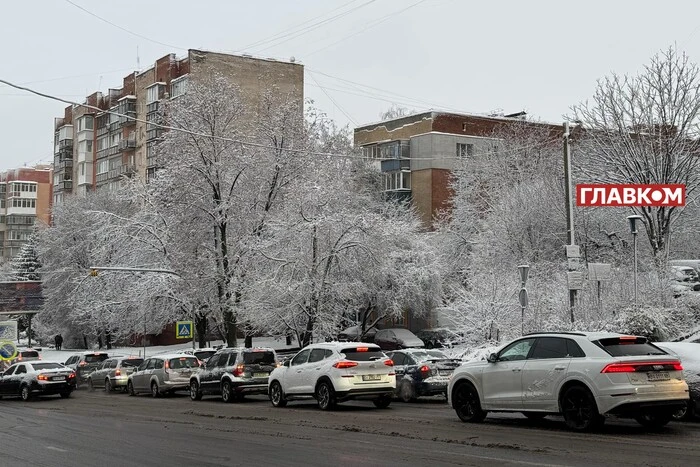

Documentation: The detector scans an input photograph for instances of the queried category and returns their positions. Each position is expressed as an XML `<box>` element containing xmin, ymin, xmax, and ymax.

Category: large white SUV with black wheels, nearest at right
<box><xmin>448</xmin><ymin>332</ymin><xmax>689</xmax><ymax>431</ymax></box>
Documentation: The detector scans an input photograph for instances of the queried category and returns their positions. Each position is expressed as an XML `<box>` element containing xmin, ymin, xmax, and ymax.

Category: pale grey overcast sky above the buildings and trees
<box><xmin>0</xmin><ymin>0</ymin><xmax>700</xmax><ymax>170</ymax></box>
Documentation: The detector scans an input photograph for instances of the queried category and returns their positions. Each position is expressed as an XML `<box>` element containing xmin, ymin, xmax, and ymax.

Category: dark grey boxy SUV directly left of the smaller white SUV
<box><xmin>190</xmin><ymin>347</ymin><xmax>277</xmax><ymax>402</ymax></box>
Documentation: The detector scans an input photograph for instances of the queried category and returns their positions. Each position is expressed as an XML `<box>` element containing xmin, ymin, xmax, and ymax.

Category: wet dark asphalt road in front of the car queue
<box><xmin>0</xmin><ymin>390</ymin><xmax>700</xmax><ymax>467</ymax></box>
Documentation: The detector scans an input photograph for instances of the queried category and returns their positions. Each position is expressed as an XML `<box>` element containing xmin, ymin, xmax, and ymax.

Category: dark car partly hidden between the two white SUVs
<box><xmin>387</xmin><ymin>349</ymin><xmax>461</xmax><ymax>402</ymax></box>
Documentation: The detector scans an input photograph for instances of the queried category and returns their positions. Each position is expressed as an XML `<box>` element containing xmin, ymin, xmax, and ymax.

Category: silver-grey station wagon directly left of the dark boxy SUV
<box><xmin>126</xmin><ymin>353</ymin><xmax>199</xmax><ymax>397</ymax></box>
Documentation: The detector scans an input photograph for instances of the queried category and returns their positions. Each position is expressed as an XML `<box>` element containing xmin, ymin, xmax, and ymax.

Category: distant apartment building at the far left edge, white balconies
<box><xmin>0</xmin><ymin>165</ymin><xmax>52</xmax><ymax>261</ymax></box>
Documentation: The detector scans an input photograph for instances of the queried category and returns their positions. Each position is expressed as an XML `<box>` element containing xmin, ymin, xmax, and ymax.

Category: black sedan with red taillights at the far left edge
<box><xmin>0</xmin><ymin>360</ymin><xmax>76</xmax><ymax>401</ymax></box>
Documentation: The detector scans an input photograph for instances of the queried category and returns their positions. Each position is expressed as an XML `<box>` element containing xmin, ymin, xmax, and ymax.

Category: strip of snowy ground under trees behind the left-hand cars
<box><xmin>18</xmin><ymin>337</ymin><xmax>298</xmax><ymax>363</ymax></box>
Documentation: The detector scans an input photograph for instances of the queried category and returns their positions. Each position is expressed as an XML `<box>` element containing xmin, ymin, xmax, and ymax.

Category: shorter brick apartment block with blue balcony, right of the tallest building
<box><xmin>354</xmin><ymin>111</ymin><xmax>561</xmax><ymax>227</ymax></box>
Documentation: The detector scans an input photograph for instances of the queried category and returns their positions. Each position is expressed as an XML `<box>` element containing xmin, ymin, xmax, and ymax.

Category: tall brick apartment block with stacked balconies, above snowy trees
<box><xmin>53</xmin><ymin>50</ymin><xmax>304</xmax><ymax>202</ymax></box>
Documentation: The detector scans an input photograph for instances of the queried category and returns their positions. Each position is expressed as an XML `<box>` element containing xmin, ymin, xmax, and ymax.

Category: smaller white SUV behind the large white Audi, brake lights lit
<box><xmin>268</xmin><ymin>342</ymin><xmax>396</xmax><ymax>410</ymax></box>
